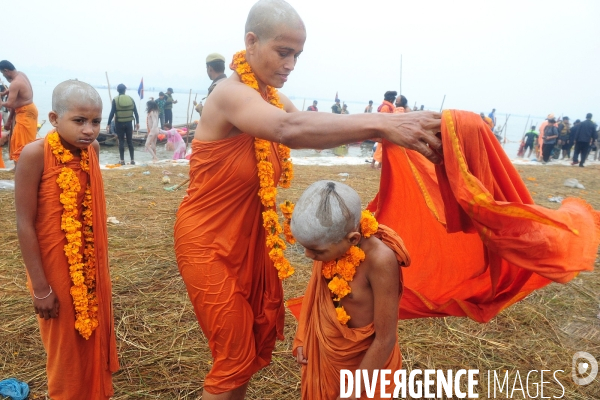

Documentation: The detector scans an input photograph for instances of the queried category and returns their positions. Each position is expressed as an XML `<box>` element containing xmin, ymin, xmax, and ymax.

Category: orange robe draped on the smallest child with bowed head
<box><xmin>288</xmin><ymin>225</ymin><xmax>410</xmax><ymax>400</ymax></box>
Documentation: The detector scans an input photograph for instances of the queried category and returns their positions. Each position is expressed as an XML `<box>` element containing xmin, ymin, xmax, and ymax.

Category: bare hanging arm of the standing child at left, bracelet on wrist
<box><xmin>15</xmin><ymin>141</ymin><xmax>59</xmax><ymax>319</ymax></box>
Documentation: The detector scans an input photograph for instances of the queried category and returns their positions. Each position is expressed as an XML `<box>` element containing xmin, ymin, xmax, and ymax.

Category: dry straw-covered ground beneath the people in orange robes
<box><xmin>0</xmin><ymin>164</ymin><xmax>600</xmax><ymax>399</ymax></box>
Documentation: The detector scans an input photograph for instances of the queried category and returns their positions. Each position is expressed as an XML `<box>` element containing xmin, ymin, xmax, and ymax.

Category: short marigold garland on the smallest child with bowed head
<box><xmin>321</xmin><ymin>210</ymin><xmax>379</xmax><ymax>325</ymax></box>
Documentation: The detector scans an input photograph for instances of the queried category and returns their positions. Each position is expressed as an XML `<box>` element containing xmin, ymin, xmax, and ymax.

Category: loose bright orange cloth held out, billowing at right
<box><xmin>370</xmin><ymin>111</ymin><xmax>600</xmax><ymax>322</ymax></box>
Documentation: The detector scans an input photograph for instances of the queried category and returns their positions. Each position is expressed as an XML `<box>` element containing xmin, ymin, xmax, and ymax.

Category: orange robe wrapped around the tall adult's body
<box><xmin>175</xmin><ymin>134</ymin><xmax>284</xmax><ymax>394</ymax></box>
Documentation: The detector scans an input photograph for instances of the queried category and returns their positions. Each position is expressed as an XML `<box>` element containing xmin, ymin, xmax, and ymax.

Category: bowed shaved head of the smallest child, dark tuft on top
<box><xmin>291</xmin><ymin>181</ymin><xmax>361</xmax><ymax>247</ymax></box>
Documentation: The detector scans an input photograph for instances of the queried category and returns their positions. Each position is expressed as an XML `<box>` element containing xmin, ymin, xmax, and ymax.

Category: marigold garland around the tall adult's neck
<box><xmin>230</xmin><ymin>50</ymin><xmax>296</xmax><ymax>279</ymax></box>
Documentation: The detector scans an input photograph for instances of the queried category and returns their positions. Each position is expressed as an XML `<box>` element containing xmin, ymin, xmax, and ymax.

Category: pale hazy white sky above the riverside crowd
<box><xmin>0</xmin><ymin>0</ymin><xmax>600</xmax><ymax>125</ymax></box>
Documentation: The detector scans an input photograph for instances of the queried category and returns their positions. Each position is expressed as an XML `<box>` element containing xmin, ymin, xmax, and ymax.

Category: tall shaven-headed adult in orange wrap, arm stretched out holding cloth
<box><xmin>175</xmin><ymin>0</ymin><xmax>440</xmax><ymax>400</ymax></box>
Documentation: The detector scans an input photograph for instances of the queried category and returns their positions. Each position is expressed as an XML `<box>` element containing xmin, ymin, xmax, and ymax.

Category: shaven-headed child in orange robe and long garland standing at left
<box><xmin>15</xmin><ymin>80</ymin><xmax>119</xmax><ymax>400</ymax></box>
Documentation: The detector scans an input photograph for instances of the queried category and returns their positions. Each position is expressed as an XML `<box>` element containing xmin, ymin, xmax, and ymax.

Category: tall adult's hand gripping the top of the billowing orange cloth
<box><xmin>383</xmin><ymin>111</ymin><xmax>442</xmax><ymax>164</ymax></box>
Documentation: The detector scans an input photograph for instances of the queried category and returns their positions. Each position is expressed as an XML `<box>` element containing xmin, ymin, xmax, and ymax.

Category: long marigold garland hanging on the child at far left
<box><xmin>48</xmin><ymin>132</ymin><xmax>98</xmax><ymax>339</ymax></box>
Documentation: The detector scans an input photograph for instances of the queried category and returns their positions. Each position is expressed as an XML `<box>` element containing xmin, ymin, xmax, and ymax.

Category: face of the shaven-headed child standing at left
<box><xmin>48</xmin><ymin>102</ymin><xmax>102</xmax><ymax>150</ymax></box>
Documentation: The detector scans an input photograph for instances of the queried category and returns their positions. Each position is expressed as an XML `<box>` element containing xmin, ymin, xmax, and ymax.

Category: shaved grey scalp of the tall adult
<box><xmin>246</xmin><ymin>0</ymin><xmax>305</xmax><ymax>40</ymax></box>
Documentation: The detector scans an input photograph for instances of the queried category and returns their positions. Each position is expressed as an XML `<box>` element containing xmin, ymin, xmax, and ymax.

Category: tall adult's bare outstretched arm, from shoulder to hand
<box><xmin>213</xmin><ymin>82</ymin><xmax>441</xmax><ymax>162</ymax></box>
